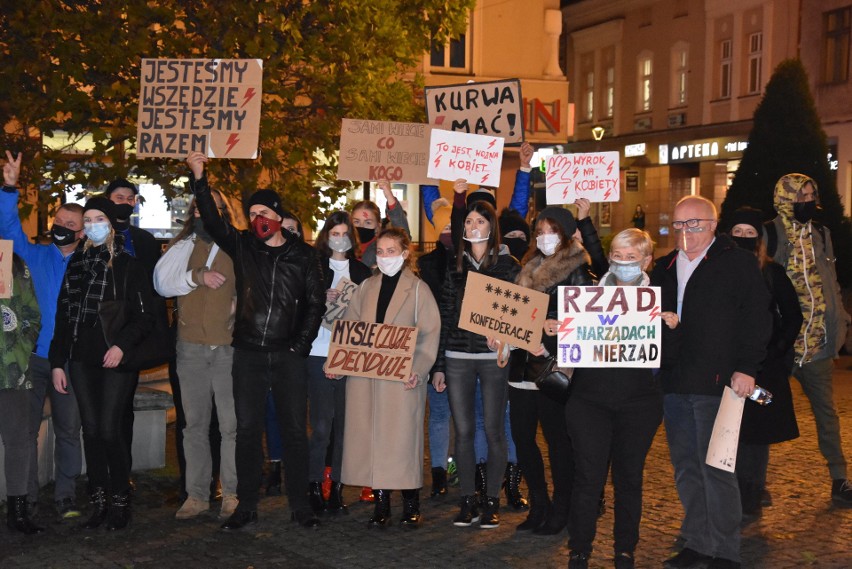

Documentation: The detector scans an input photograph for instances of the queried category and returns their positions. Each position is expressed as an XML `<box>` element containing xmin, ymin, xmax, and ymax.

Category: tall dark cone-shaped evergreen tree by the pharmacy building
<box><xmin>721</xmin><ymin>59</ymin><xmax>852</xmax><ymax>286</ymax></box>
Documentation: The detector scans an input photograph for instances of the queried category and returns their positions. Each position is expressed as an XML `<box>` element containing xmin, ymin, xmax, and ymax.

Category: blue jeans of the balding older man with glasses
<box><xmin>663</xmin><ymin>393</ymin><xmax>742</xmax><ymax>562</ymax></box>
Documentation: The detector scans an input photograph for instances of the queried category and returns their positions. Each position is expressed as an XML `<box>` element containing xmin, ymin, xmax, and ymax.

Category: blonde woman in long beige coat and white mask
<box><xmin>341</xmin><ymin>228</ymin><xmax>441</xmax><ymax>528</ymax></box>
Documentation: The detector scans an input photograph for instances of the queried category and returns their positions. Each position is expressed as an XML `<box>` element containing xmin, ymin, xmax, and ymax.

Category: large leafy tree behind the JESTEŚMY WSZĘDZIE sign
<box><xmin>0</xmin><ymin>0</ymin><xmax>475</xmax><ymax>229</ymax></box>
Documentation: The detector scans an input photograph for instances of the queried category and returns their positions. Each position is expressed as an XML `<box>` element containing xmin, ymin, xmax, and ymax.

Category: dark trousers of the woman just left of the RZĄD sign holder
<box><xmin>509</xmin><ymin>387</ymin><xmax>574</xmax><ymax>508</ymax></box>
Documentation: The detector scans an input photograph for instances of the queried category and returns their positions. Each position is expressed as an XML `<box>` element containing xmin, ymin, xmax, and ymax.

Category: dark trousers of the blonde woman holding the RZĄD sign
<box><xmin>566</xmin><ymin>392</ymin><xmax>663</xmax><ymax>553</ymax></box>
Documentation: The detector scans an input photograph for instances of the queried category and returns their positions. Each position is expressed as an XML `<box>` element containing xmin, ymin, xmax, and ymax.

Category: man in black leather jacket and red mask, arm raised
<box><xmin>187</xmin><ymin>152</ymin><xmax>326</xmax><ymax>530</ymax></box>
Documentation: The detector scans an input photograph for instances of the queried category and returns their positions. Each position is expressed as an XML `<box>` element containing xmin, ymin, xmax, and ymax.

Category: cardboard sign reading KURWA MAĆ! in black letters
<box><xmin>425</xmin><ymin>79</ymin><xmax>524</xmax><ymax>146</ymax></box>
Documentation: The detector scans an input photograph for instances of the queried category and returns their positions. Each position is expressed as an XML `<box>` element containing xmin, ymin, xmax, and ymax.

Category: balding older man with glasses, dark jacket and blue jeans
<box><xmin>651</xmin><ymin>196</ymin><xmax>771</xmax><ymax>569</ymax></box>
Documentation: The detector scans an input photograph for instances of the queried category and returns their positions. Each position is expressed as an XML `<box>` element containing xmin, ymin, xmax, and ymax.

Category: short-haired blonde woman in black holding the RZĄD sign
<box><xmin>564</xmin><ymin>228</ymin><xmax>664</xmax><ymax>569</ymax></box>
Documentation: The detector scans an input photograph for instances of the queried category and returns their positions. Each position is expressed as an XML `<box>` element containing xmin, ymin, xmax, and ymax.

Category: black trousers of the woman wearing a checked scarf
<box><xmin>70</xmin><ymin>362</ymin><xmax>139</xmax><ymax>494</ymax></box>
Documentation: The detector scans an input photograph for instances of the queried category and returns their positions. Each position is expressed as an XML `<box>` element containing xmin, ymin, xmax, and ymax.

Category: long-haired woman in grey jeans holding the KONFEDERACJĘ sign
<box><xmin>432</xmin><ymin>201</ymin><xmax>521</xmax><ymax>529</ymax></box>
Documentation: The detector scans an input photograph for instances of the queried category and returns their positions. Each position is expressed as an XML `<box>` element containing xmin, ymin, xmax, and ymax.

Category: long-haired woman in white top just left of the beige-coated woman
<box><xmin>308</xmin><ymin>211</ymin><xmax>370</xmax><ymax>514</ymax></box>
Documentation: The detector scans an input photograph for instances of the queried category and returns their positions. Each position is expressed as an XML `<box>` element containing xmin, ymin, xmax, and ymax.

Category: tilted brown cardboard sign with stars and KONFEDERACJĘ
<box><xmin>458</xmin><ymin>271</ymin><xmax>548</xmax><ymax>350</ymax></box>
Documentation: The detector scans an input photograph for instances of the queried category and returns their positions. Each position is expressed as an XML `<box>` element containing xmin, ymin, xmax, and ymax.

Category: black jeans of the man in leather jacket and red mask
<box><xmin>233</xmin><ymin>348</ymin><xmax>309</xmax><ymax>511</ymax></box>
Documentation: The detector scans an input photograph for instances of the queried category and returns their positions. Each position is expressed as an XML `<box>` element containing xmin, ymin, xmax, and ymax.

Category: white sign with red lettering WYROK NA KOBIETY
<box><xmin>545</xmin><ymin>152</ymin><xmax>621</xmax><ymax>205</ymax></box>
